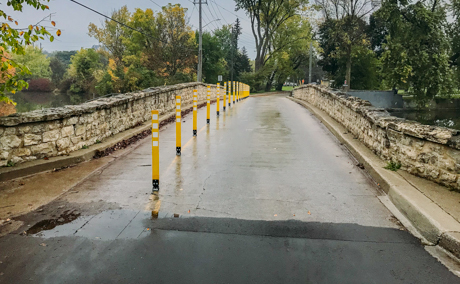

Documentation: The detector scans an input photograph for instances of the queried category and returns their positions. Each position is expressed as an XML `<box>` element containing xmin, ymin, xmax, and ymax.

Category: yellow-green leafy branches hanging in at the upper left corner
<box><xmin>0</xmin><ymin>0</ymin><xmax>61</xmax><ymax>103</ymax></box>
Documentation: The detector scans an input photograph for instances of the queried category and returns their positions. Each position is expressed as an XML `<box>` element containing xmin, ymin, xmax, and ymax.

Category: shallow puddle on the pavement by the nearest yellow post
<box><xmin>27</xmin><ymin>209</ymin><xmax>169</xmax><ymax>240</ymax></box>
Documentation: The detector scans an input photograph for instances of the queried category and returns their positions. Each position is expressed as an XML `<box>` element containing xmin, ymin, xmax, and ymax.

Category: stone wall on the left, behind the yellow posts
<box><xmin>0</xmin><ymin>83</ymin><xmax>218</xmax><ymax>166</ymax></box>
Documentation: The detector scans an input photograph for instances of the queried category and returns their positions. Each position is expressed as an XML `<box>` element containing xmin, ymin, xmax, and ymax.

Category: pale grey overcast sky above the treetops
<box><xmin>0</xmin><ymin>0</ymin><xmax>255</xmax><ymax>59</ymax></box>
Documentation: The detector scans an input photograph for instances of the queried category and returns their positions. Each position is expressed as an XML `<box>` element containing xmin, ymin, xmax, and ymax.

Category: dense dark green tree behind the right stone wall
<box><xmin>379</xmin><ymin>1</ymin><xmax>453</xmax><ymax>105</ymax></box>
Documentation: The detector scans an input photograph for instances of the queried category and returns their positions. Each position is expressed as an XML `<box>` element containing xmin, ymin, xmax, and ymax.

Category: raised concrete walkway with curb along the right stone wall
<box><xmin>289</xmin><ymin>98</ymin><xmax>460</xmax><ymax>258</ymax></box>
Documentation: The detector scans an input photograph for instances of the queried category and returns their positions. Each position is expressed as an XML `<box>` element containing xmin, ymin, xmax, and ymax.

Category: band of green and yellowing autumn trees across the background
<box><xmin>0</xmin><ymin>0</ymin><xmax>460</xmax><ymax>115</ymax></box>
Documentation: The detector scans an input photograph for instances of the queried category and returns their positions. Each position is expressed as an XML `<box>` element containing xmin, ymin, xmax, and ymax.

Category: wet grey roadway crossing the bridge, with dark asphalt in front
<box><xmin>0</xmin><ymin>95</ymin><xmax>460</xmax><ymax>283</ymax></box>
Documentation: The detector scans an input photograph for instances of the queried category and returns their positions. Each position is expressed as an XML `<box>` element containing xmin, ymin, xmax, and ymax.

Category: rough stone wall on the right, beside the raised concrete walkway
<box><xmin>292</xmin><ymin>85</ymin><xmax>460</xmax><ymax>190</ymax></box>
